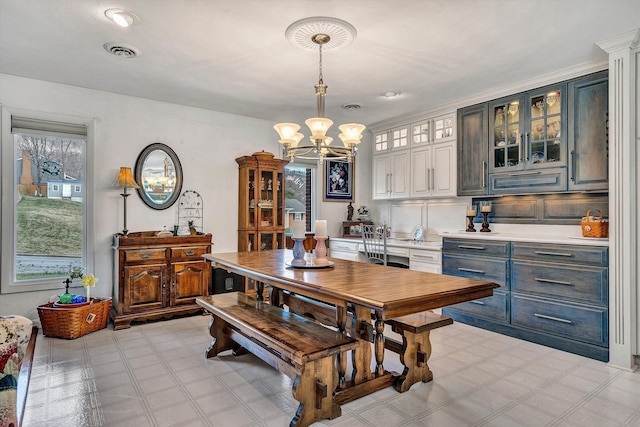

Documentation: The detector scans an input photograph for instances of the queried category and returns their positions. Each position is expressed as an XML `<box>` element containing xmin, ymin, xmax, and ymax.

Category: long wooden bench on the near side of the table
<box><xmin>196</xmin><ymin>292</ymin><xmax>359</xmax><ymax>427</ymax></box>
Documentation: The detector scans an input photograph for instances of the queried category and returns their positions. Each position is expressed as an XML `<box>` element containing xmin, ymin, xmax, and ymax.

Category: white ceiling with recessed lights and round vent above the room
<box><xmin>0</xmin><ymin>0</ymin><xmax>640</xmax><ymax>124</ymax></box>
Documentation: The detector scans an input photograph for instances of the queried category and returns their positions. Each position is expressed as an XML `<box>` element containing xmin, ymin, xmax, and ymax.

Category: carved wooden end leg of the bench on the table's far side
<box><xmin>394</xmin><ymin>330</ymin><xmax>433</xmax><ymax>393</ymax></box>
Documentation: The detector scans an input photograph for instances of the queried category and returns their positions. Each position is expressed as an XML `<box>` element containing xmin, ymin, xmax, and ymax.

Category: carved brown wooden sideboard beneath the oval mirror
<box><xmin>111</xmin><ymin>231</ymin><xmax>211</xmax><ymax>330</ymax></box>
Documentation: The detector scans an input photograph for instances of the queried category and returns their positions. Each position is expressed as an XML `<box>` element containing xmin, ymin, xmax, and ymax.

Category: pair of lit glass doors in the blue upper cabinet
<box><xmin>489</xmin><ymin>85</ymin><xmax>567</xmax><ymax>173</ymax></box>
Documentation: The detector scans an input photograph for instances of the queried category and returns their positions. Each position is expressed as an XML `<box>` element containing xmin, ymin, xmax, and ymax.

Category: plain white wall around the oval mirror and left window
<box><xmin>0</xmin><ymin>74</ymin><xmax>371</xmax><ymax>320</ymax></box>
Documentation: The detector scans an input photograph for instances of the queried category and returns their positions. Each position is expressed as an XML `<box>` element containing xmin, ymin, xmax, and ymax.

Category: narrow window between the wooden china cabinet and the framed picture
<box><xmin>284</xmin><ymin>164</ymin><xmax>316</xmax><ymax>232</ymax></box>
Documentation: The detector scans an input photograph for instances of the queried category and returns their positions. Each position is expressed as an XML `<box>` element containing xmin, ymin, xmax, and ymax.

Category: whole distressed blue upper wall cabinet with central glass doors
<box><xmin>458</xmin><ymin>72</ymin><xmax>608</xmax><ymax>196</ymax></box>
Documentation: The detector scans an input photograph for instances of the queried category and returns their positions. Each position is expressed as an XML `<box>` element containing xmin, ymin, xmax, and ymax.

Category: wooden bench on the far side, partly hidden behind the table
<box><xmin>277</xmin><ymin>291</ymin><xmax>453</xmax><ymax>393</ymax></box>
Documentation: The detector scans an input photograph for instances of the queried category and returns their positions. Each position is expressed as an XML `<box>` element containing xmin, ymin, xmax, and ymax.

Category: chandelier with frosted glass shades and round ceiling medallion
<box><xmin>273</xmin><ymin>17</ymin><xmax>365</xmax><ymax>162</ymax></box>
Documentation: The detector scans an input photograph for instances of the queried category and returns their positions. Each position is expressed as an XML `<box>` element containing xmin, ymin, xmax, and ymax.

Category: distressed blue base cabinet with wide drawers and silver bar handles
<box><xmin>442</xmin><ymin>238</ymin><xmax>609</xmax><ymax>362</ymax></box>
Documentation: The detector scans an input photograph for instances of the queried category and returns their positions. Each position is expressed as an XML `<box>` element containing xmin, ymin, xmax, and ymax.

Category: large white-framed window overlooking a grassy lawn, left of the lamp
<box><xmin>1</xmin><ymin>109</ymin><xmax>91</xmax><ymax>293</ymax></box>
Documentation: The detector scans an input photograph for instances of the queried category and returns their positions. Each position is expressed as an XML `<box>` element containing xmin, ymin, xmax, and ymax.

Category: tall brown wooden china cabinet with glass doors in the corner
<box><xmin>236</xmin><ymin>151</ymin><xmax>288</xmax><ymax>292</ymax></box>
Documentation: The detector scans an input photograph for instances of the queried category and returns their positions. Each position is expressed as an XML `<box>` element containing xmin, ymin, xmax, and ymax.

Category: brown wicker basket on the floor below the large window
<box><xmin>38</xmin><ymin>298</ymin><xmax>111</xmax><ymax>339</ymax></box>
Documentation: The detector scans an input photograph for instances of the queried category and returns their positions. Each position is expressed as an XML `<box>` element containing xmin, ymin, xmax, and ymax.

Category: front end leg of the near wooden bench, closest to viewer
<box><xmin>290</xmin><ymin>357</ymin><xmax>342</xmax><ymax>427</ymax></box>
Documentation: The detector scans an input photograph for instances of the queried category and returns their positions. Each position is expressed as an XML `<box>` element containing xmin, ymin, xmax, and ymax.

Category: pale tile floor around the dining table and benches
<box><xmin>23</xmin><ymin>316</ymin><xmax>640</xmax><ymax>427</ymax></box>
